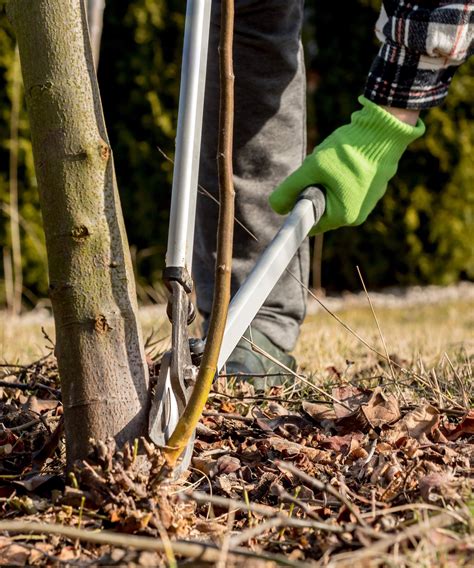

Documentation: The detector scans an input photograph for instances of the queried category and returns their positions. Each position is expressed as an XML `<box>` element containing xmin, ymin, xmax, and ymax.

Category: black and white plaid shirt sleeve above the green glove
<box><xmin>364</xmin><ymin>0</ymin><xmax>474</xmax><ymax>109</ymax></box>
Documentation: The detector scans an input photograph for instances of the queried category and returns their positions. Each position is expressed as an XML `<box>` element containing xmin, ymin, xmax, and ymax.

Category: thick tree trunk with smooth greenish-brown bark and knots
<box><xmin>8</xmin><ymin>0</ymin><xmax>149</xmax><ymax>465</ymax></box>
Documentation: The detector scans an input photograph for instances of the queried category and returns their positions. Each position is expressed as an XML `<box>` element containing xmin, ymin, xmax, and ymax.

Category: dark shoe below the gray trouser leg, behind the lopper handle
<box><xmin>226</xmin><ymin>328</ymin><xmax>296</xmax><ymax>390</ymax></box>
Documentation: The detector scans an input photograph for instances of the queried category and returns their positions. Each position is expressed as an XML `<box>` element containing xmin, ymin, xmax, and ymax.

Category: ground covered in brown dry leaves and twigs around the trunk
<box><xmin>0</xmin><ymin>296</ymin><xmax>474</xmax><ymax>567</ymax></box>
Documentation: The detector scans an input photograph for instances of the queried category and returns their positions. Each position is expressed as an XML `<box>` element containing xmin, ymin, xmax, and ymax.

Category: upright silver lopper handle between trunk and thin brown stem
<box><xmin>166</xmin><ymin>0</ymin><xmax>212</xmax><ymax>274</ymax></box>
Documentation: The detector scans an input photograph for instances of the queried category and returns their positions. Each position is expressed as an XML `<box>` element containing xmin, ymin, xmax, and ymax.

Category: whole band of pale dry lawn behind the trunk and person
<box><xmin>0</xmin><ymin>292</ymin><xmax>474</xmax><ymax>372</ymax></box>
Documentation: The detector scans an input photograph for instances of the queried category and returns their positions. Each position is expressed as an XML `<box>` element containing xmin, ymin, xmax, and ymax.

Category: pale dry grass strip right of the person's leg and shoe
<box><xmin>295</xmin><ymin>301</ymin><xmax>474</xmax><ymax>373</ymax></box>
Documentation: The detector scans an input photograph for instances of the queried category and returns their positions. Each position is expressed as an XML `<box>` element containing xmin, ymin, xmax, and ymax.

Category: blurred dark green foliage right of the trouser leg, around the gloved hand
<box><xmin>307</xmin><ymin>0</ymin><xmax>474</xmax><ymax>288</ymax></box>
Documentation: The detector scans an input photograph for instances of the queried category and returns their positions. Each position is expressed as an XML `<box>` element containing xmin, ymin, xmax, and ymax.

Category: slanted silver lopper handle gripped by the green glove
<box><xmin>217</xmin><ymin>187</ymin><xmax>326</xmax><ymax>372</ymax></box>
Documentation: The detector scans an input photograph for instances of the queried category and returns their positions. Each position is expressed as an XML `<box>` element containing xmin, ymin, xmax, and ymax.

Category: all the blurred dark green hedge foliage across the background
<box><xmin>0</xmin><ymin>0</ymin><xmax>474</xmax><ymax>306</ymax></box>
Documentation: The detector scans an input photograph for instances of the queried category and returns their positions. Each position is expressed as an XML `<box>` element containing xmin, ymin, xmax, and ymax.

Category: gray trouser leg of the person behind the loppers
<box><xmin>193</xmin><ymin>0</ymin><xmax>309</xmax><ymax>351</ymax></box>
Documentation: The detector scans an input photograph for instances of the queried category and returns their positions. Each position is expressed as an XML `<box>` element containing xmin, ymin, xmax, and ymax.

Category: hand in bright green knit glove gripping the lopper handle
<box><xmin>269</xmin><ymin>97</ymin><xmax>425</xmax><ymax>235</ymax></box>
